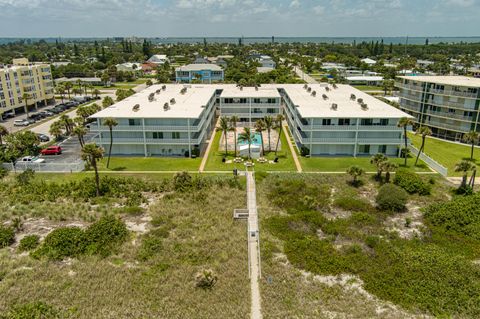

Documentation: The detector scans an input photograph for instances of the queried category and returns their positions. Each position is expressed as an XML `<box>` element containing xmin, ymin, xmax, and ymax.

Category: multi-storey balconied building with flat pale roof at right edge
<box><xmin>395</xmin><ymin>76</ymin><xmax>480</xmax><ymax>141</ymax></box>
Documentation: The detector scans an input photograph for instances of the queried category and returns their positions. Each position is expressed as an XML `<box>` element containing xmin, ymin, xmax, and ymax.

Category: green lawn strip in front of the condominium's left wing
<box><xmin>98</xmin><ymin>157</ymin><xmax>202</xmax><ymax>171</ymax></box>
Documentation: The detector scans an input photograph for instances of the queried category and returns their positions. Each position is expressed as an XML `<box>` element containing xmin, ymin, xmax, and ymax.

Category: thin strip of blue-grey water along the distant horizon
<box><xmin>0</xmin><ymin>36</ymin><xmax>480</xmax><ymax>44</ymax></box>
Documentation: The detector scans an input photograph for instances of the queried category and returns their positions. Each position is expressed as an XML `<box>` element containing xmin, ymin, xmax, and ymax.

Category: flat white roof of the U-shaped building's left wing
<box><xmin>92</xmin><ymin>84</ymin><xmax>215</xmax><ymax>118</ymax></box>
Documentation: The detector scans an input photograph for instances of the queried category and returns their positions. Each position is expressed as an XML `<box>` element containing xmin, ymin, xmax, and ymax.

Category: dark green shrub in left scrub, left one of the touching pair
<box><xmin>33</xmin><ymin>227</ymin><xmax>85</xmax><ymax>260</ymax></box>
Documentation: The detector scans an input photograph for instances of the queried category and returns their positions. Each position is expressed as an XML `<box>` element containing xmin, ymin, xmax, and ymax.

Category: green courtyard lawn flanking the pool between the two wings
<box><xmin>205</xmin><ymin>132</ymin><xmax>296</xmax><ymax>171</ymax></box>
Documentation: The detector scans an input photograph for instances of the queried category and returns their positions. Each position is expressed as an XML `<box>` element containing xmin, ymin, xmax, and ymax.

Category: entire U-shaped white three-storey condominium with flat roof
<box><xmin>92</xmin><ymin>84</ymin><xmax>410</xmax><ymax>156</ymax></box>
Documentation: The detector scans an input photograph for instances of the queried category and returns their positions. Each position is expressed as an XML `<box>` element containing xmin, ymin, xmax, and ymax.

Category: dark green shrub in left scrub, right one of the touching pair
<box><xmin>85</xmin><ymin>216</ymin><xmax>128</xmax><ymax>256</ymax></box>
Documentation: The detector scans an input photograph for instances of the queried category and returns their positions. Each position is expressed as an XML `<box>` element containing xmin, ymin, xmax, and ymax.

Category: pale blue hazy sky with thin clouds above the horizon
<box><xmin>0</xmin><ymin>0</ymin><xmax>480</xmax><ymax>37</ymax></box>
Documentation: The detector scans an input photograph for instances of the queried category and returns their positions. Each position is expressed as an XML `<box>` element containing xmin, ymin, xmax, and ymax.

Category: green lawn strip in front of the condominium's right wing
<box><xmin>300</xmin><ymin>157</ymin><xmax>430</xmax><ymax>172</ymax></box>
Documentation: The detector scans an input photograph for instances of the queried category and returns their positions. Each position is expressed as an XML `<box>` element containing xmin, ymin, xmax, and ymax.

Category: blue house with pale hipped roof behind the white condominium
<box><xmin>175</xmin><ymin>63</ymin><xmax>224</xmax><ymax>83</ymax></box>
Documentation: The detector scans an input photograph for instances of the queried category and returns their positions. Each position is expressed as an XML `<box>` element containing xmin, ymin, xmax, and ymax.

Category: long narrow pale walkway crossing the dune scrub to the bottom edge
<box><xmin>247</xmin><ymin>172</ymin><xmax>262</xmax><ymax>319</ymax></box>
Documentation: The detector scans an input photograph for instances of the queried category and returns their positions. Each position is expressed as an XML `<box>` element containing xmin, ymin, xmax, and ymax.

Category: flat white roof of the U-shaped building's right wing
<box><xmin>278</xmin><ymin>84</ymin><xmax>411</xmax><ymax>118</ymax></box>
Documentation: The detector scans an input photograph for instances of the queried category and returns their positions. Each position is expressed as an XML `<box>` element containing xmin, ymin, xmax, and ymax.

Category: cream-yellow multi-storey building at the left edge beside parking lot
<box><xmin>0</xmin><ymin>59</ymin><xmax>54</xmax><ymax>114</ymax></box>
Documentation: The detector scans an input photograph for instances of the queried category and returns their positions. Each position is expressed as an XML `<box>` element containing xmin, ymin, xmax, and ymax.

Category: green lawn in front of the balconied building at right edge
<box><xmin>408</xmin><ymin>133</ymin><xmax>480</xmax><ymax>176</ymax></box>
